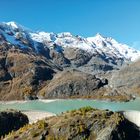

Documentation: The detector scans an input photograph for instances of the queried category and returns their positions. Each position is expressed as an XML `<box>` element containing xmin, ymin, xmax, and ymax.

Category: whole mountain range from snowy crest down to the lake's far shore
<box><xmin>0</xmin><ymin>22</ymin><xmax>140</xmax><ymax>101</ymax></box>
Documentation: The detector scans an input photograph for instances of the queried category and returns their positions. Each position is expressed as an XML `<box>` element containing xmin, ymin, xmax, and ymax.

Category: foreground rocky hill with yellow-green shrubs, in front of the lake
<box><xmin>5</xmin><ymin>107</ymin><xmax>140</xmax><ymax>140</ymax></box>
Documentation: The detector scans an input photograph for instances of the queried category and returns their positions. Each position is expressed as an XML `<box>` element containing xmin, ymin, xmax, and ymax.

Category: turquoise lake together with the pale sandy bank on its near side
<box><xmin>0</xmin><ymin>97</ymin><xmax>140</xmax><ymax>123</ymax></box>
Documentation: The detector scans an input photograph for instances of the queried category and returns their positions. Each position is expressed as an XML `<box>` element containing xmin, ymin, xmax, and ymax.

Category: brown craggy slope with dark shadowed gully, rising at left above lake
<box><xmin>0</xmin><ymin>45</ymin><xmax>59</xmax><ymax>100</ymax></box>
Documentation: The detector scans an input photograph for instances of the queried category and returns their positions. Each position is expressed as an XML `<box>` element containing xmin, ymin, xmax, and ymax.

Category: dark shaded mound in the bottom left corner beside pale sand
<box><xmin>0</xmin><ymin>110</ymin><xmax>29</xmax><ymax>137</ymax></box>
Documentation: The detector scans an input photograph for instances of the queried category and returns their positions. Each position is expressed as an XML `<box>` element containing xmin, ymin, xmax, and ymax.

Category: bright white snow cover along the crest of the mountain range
<box><xmin>2</xmin><ymin>22</ymin><xmax>140</xmax><ymax>61</ymax></box>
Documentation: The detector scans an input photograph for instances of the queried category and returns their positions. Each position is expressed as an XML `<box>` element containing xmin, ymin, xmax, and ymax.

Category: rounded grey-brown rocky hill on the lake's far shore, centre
<box><xmin>40</xmin><ymin>69</ymin><xmax>107</xmax><ymax>98</ymax></box>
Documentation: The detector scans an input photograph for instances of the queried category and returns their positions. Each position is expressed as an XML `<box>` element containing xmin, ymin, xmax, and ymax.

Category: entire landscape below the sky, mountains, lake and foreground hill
<box><xmin>0</xmin><ymin>22</ymin><xmax>140</xmax><ymax>140</ymax></box>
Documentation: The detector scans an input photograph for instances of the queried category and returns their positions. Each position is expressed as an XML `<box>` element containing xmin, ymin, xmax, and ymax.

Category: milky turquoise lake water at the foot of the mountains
<box><xmin>0</xmin><ymin>98</ymin><xmax>140</xmax><ymax>114</ymax></box>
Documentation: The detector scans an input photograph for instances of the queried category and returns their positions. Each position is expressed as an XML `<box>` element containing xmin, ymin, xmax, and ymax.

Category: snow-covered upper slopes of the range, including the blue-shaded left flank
<box><xmin>0</xmin><ymin>22</ymin><xmax>140</xmax><ymax>64</ymax></box>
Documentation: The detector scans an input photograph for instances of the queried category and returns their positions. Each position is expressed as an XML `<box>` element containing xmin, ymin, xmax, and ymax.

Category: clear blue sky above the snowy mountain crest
<box><xmin>0</xmin><ymin>0</ymin><xmax>140</xmax><ymax>49</ymax></box>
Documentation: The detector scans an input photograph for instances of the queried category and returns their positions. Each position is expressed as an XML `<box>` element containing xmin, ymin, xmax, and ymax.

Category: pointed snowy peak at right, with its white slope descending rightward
<box><xmin>87</xmin><ymin>33</ymin><xmax>140</xmax><ymax>61</ymax></box>
